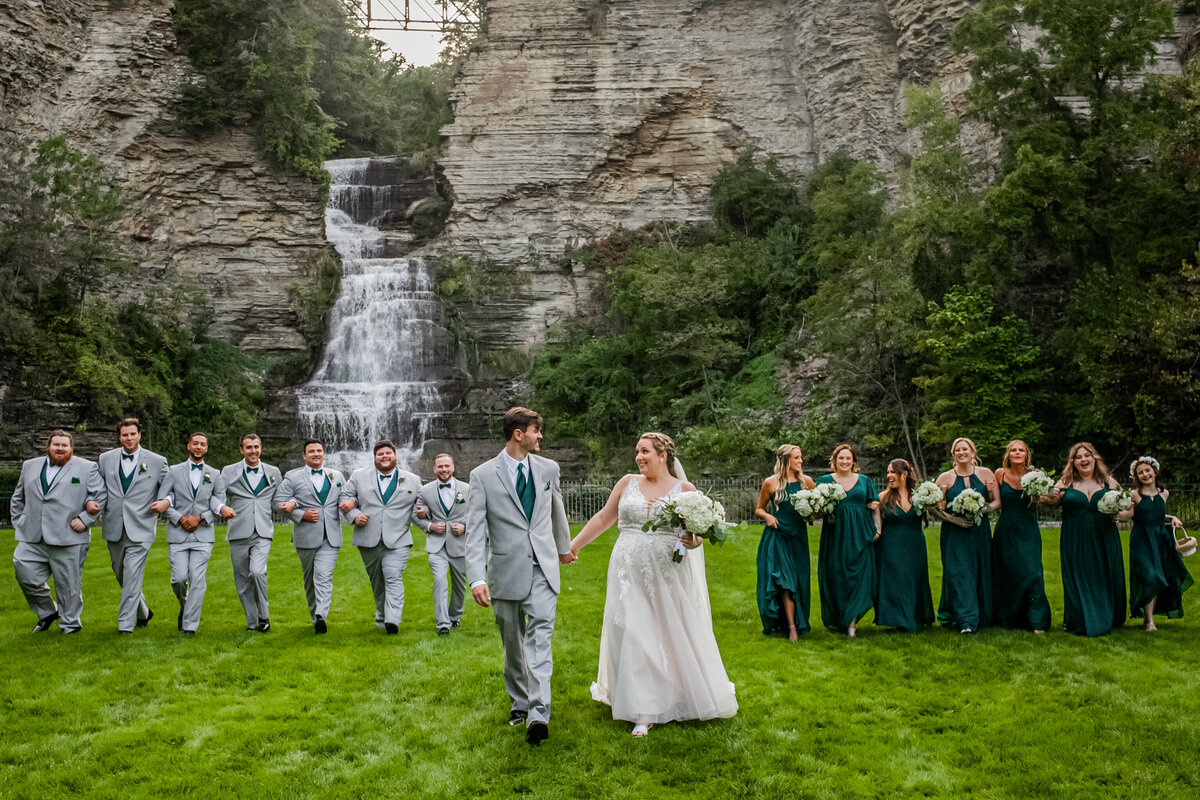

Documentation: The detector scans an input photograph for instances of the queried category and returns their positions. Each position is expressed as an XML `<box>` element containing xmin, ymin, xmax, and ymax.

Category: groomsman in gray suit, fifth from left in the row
<box><xmin>275</xmin><ymin>439</ymin><xmax>346</xmax><ymax>633</ymax></box>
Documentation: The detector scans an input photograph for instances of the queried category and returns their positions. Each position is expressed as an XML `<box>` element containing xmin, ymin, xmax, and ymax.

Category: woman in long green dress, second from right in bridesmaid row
<box><xmin>1057</xmin><ymin>441</ymin><xmax>1129</xmax><ymax>636</ymax></box>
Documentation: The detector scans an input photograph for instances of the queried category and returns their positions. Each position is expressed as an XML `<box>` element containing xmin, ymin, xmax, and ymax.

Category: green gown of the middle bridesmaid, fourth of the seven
<box><xmin>937</xmin><ymin>473</ymin><xmax>992</xmax><ymax>632</ymax></box>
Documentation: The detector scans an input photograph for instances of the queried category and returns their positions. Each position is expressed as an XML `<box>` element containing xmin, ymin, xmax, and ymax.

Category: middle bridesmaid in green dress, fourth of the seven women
<box><xmin>937</xmin><ymin>437</ymin><xmax>1000</xmax><ymax>633</ymax></box>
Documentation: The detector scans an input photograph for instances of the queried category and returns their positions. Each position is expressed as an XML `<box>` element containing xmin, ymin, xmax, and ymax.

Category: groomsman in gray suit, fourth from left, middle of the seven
<box><xmin>221</xmin><ymin>433</ymin><xmax>282</xmax><ymax>633</ymax></box>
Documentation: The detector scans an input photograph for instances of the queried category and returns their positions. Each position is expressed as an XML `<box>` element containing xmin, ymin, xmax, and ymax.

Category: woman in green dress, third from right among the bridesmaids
<box><xmin>991</xmin><ymin>439</ymin><xmax>1050</xmax><ymax>633</ymax></box>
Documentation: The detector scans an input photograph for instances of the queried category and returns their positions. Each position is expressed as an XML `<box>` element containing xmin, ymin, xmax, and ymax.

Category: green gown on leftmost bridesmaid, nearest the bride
<box><xmin>757</xmin><ymin>481</ymin><xmax>812</xmax><ymax>633</ymax></box>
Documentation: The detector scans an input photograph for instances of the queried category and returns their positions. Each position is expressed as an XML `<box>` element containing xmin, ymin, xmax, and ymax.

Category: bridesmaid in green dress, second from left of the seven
<box><xmin>817</xmin><ymin>445</ymin><xmax>880</xmax><ymax>638</ymax></box>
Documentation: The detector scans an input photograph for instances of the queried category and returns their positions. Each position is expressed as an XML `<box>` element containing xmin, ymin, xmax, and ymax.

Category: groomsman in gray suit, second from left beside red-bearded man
<box><xmin>100</xmin><ymin>417</ymin><xmax>170</xmax><ymax>633</ymax></box>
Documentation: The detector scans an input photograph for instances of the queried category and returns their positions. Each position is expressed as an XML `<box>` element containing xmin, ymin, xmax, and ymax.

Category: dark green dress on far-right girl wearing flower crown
<box><xmin>1129</xmin><ymin>494</ymin><xmax>1192</xmax><ymax>619</ymax></box>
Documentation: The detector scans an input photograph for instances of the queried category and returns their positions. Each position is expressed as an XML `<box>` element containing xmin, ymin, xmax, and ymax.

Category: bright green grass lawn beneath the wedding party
<box><xmin>0</xmin><ymin>528</ymin><xmax>1200</xmax><ymax>800</ymax></box>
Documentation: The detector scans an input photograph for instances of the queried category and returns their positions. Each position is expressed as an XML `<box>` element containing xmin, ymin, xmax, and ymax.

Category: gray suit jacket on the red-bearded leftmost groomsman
<box><xmin>8</xmin><ymin>456</ymin><xmax>107</xmax><ymax>547</ymax></box>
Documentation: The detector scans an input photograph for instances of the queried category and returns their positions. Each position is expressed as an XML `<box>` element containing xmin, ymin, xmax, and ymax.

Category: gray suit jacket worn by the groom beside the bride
<box><xmin>467</xmin><ymin>453</ymin><xmax>571</xmax><ymax>600</ymax></box>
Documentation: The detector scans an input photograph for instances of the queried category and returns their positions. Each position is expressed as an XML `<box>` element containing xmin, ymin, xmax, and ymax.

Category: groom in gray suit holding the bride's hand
<box><xmin>467</xmin><ymin>408</ymin><xmax>575</xmax><ymax>745</ymax></box>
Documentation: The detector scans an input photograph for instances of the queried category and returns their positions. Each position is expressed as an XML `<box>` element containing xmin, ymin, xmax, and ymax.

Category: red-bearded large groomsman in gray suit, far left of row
<box><xmin>8</xmin><ymin>431</ymin><xmax>106</xmax><ymax>633</ymax></box>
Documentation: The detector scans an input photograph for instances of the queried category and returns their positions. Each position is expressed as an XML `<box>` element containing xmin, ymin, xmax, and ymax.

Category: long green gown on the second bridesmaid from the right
<box><xmin>1058</xmin><ymin>488</ymin><xmax>1126</xmax><ymax>636</ymax></box>
